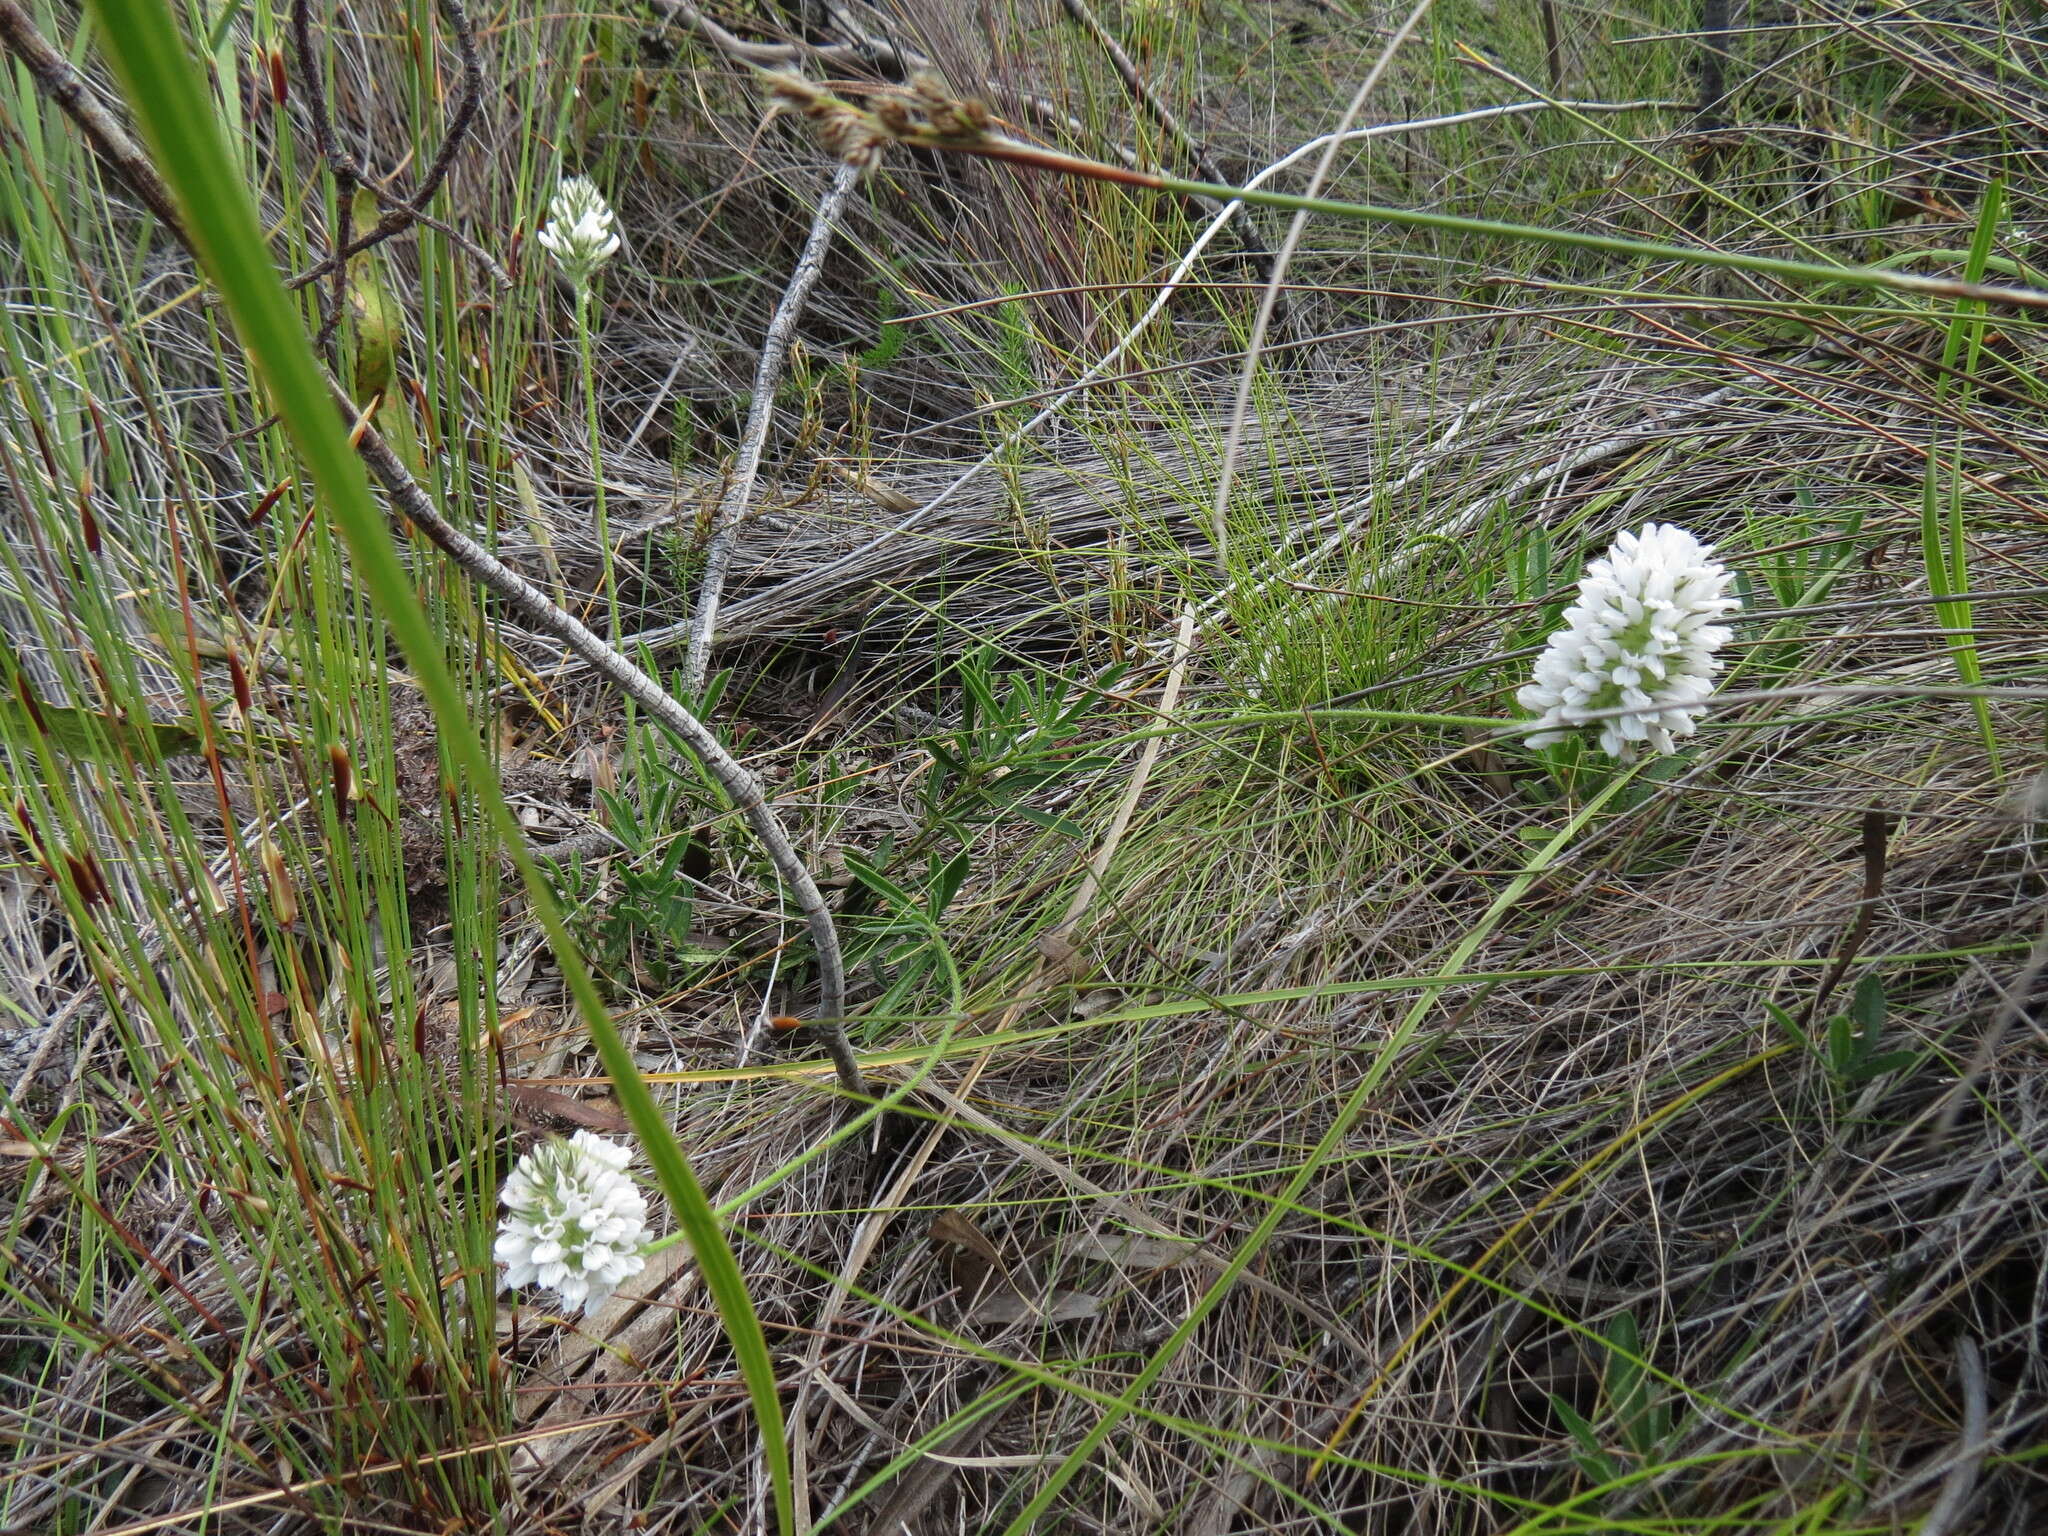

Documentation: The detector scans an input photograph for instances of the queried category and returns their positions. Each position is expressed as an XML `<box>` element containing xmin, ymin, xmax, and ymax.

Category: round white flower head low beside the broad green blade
<box><xmin>496</xmin><ymin>1130</ymin><xmax>647</xmax><ymax>1313</ymax></box>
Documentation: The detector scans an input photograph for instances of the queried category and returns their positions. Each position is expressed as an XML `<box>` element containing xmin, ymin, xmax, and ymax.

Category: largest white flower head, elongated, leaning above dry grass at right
<box><xmin>1516</xmin><ymin>522</ymin><xmax>1739</xmax><ymax>762</ymax></box>
